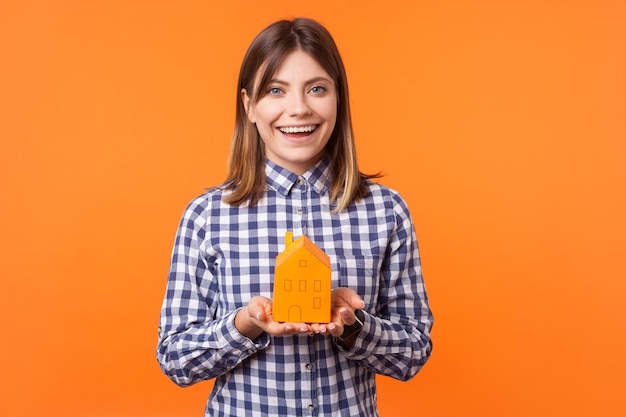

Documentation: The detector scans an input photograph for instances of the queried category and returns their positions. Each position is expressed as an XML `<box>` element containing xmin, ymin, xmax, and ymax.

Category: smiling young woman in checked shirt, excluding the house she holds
<box><xmin>157</xmin><ymin>18</ymin><xmax>432</xmax><ymax>416</ymax></box>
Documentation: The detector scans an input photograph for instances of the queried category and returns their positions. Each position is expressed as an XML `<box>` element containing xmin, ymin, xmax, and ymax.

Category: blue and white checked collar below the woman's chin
<box><xmin>265</xmin><ymin>158</ymin><xmax>330</xmax><ymax>196</ymax></box>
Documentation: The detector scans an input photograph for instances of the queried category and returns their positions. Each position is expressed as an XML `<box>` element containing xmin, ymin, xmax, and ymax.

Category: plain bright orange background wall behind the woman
<box><xmin>0</xmin><ymin>0</ymin><xmax>626</xmax><ymax>417</ymax></box>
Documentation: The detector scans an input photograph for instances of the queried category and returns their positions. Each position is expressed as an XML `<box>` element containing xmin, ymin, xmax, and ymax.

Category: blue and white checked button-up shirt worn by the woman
<box><xmin>157</xmin><ymin>160</ymin><xmax>432</xmax><ymax>417</ymax></box>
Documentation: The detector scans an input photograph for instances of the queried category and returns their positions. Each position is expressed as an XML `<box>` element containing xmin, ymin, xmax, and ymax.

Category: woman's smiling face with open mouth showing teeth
<box><xmin>241</xmin><ymin>49</ymin><xmax>337</xmax><ymax>175</ymax></box>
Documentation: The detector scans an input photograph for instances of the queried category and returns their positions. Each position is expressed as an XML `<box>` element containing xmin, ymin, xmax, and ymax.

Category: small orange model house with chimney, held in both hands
<box><xmin>272</xmin><ymin>232</ymin><xmax>331</xmax><ymax>323</ymax></box>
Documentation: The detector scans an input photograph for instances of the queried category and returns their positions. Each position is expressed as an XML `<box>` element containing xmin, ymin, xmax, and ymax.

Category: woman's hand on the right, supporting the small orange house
<box><xmin>309</xmin><ymin>287</ymin><xmax>365</xmax><ymax>337</ymax></box>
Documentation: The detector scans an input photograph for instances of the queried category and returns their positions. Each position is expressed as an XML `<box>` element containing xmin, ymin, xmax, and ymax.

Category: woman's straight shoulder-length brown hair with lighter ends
<box><xmin>225</xmin><ymin>18</ymin><xmax>380</xmax><ymax>212</ymax></box>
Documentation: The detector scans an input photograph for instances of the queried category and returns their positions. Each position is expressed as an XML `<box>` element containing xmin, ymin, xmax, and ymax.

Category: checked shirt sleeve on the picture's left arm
<box><xmin>157</xmin><ymin>198</ymin><xmax>269</xmax><ymax>386</ymax></box>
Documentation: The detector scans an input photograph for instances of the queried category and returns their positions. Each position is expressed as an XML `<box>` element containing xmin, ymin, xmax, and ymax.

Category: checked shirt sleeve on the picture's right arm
<box><xmin>334</xmin><ymin>195</ymin><xmax>433</xmax><ymax>381</ymax></box>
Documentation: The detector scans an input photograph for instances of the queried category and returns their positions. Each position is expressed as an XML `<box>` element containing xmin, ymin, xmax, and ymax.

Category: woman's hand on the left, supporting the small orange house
<box><xmin>235</xmin><ymin>295</ymin><xmax>313</xmax><ymax>340</ymax></box>
